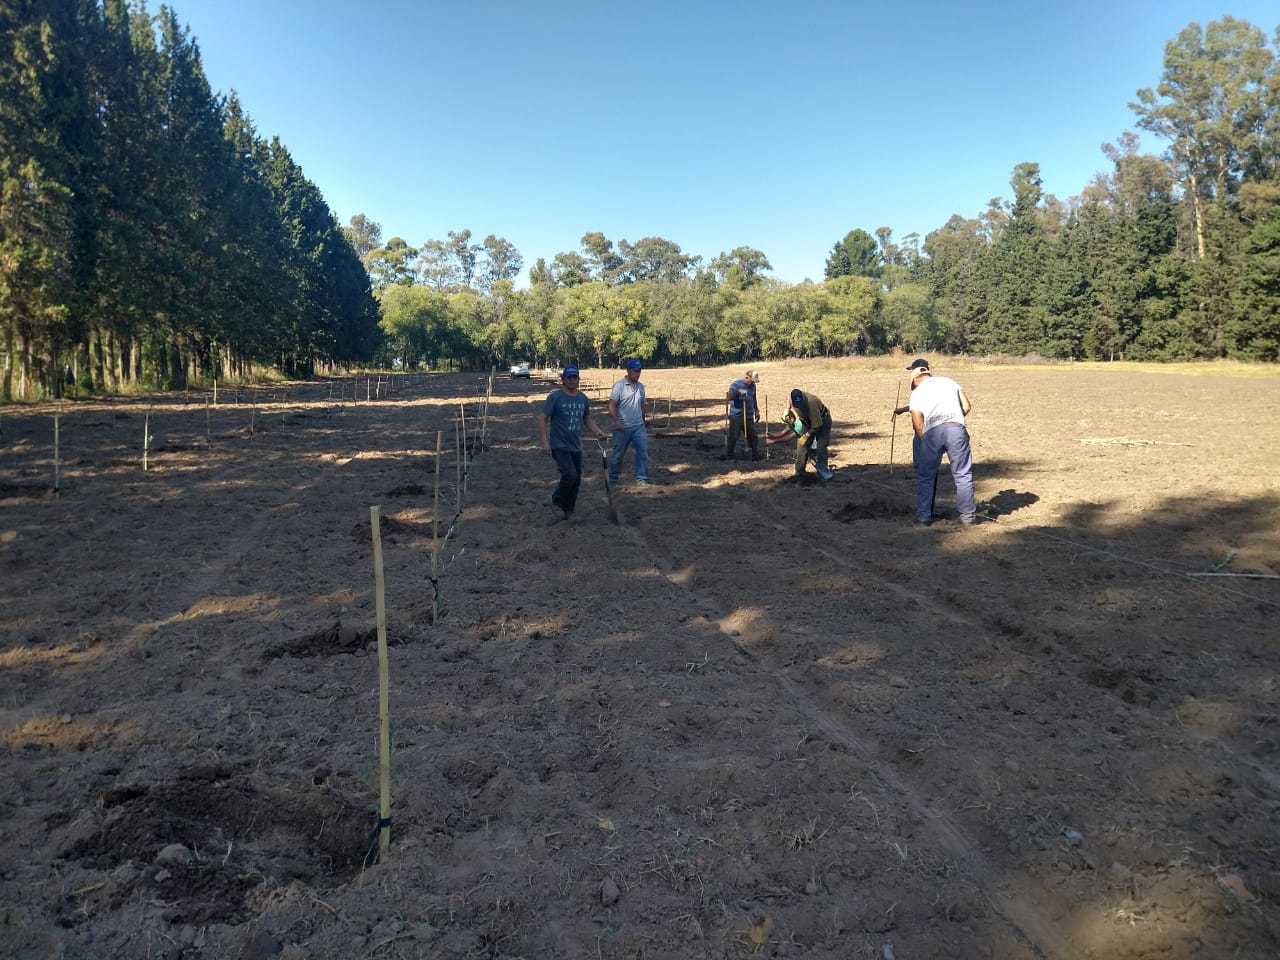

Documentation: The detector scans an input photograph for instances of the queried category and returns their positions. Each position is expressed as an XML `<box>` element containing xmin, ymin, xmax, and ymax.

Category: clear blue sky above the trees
<box><xmin>172</xmin><ymin>0</ymin><xmax>1280</xmax><ymax>285</ymax></box>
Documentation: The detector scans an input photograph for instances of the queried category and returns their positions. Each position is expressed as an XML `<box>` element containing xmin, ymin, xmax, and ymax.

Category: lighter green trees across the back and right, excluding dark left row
<box><xmin>352</xmin><ymin>17</ymin><xmax>1280</xmax><ymax>376</ymax></box>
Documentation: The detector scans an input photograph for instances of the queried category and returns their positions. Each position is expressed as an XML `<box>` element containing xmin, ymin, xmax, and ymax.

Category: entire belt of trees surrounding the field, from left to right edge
<box><xmin>0</xmin><ymin>8</ymin><xmax>1280</xmax><ymax>398</ymax></box>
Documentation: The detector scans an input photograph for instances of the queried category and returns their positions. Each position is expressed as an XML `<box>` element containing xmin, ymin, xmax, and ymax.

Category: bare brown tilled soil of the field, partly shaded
<box><xmin>0</xmin><ymin>361</ymin><xmax>1280</xmax><ymax>960</ymax></box>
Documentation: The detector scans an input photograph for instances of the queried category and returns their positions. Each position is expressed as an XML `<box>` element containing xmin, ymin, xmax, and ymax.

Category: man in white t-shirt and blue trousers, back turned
<box><xmin>911</xmin><ymin>366</ymin><xmax>978</xmax><ymax>525</ymax></box>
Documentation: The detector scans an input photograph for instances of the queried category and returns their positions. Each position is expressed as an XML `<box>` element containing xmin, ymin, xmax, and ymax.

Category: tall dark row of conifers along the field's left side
<box><xmin>0</xmin><ymin>0</ymin><xmax>381</xmax><ymax>399</ymax></box>
